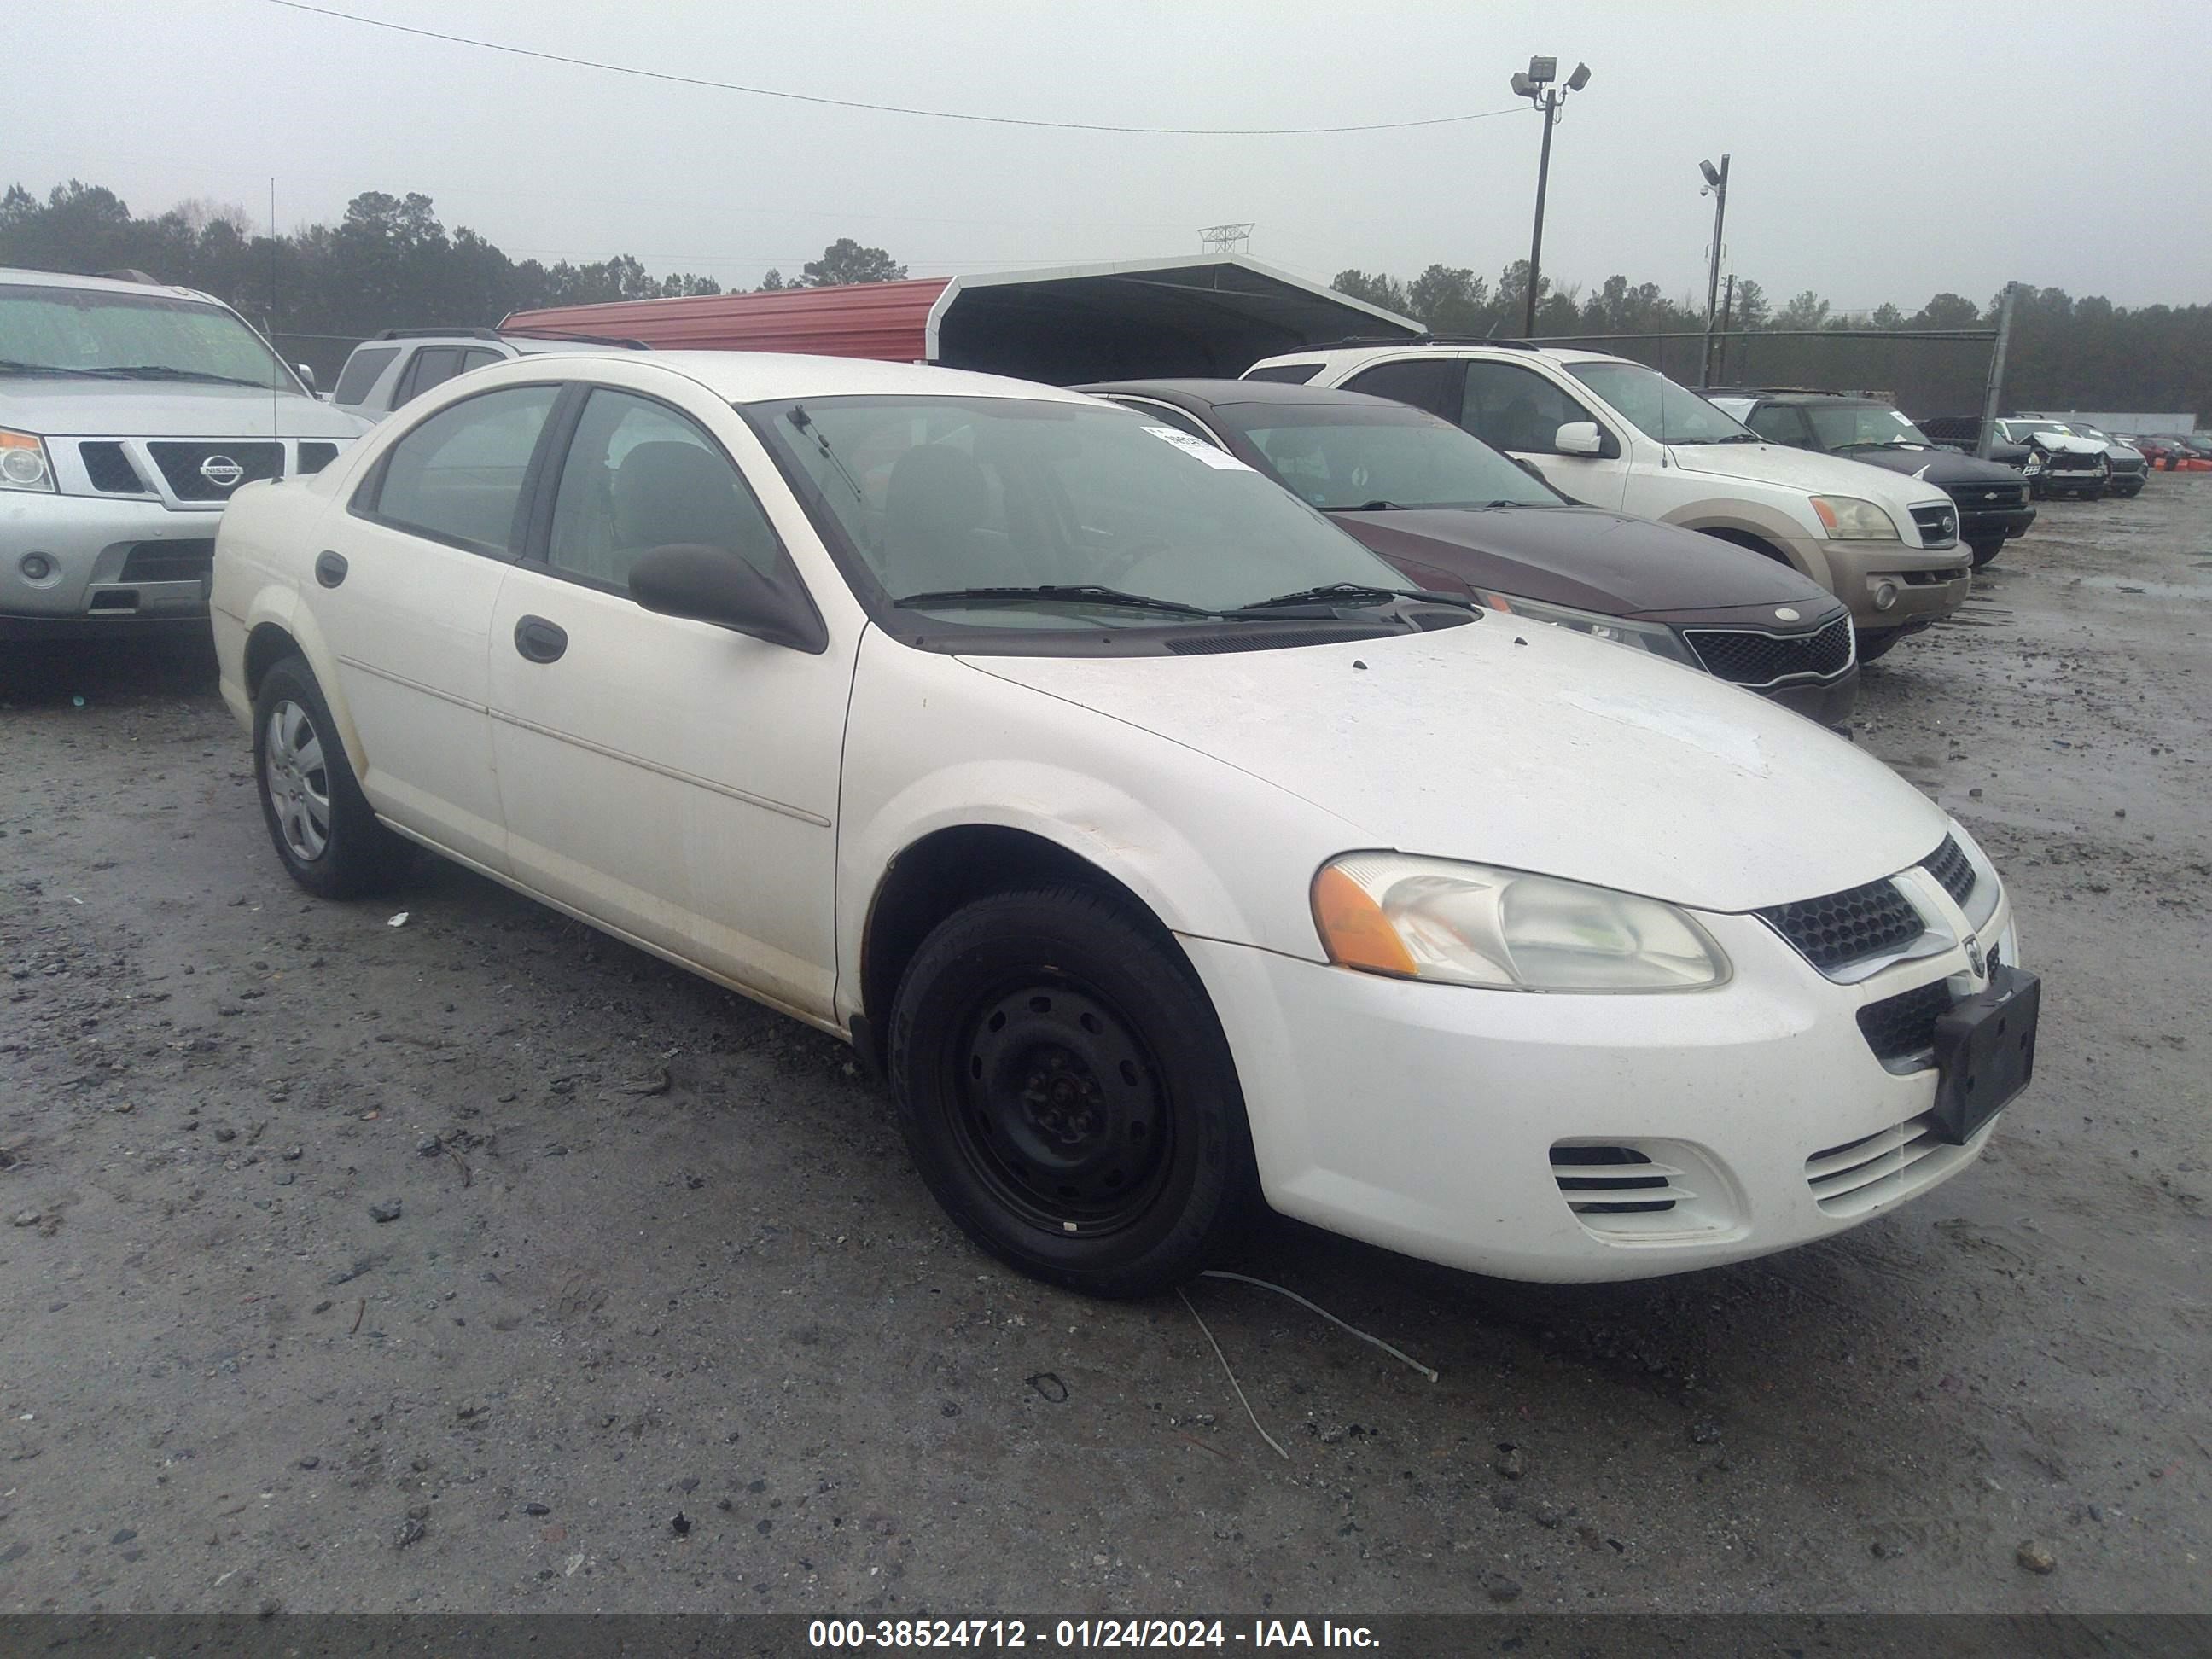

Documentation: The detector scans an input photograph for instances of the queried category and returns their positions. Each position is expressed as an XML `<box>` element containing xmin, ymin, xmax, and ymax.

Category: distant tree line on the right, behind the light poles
<box><xmin>1334</xmin><ymin>259</ymin><xmax>2212</xmax><ymax>416</ymax></box>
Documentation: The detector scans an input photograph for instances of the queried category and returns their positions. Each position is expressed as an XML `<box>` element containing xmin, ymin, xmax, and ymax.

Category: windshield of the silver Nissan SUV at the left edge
<box><xmin>0</xmin><ymin>283</ymin><xmax>301</xmax><ymax>392</ymax></box>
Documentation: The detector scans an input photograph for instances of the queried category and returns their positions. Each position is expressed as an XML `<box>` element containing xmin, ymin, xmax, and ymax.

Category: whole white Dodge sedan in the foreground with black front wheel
<box><xmin>212</xmin><ymin>354</ymin><xmax>2037</xmax><ymax>1294</ymax></box>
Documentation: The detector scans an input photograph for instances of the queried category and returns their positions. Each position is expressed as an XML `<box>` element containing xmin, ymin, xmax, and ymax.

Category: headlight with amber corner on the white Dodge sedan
<box><xmin>1312</xmin><ymin>852</ymin><xmax>1727</xmax><ymax>991</ymax></box>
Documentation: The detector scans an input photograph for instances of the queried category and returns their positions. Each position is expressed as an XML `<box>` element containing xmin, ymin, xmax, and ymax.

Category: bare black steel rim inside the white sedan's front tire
<box><xmin>952</xmin><ymin>982</ymin><xmax>1174</xmax><ymax>1237</ymax></box>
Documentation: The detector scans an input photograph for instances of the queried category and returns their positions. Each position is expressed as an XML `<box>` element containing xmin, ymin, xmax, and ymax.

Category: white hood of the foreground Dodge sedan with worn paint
<box><xmin>964</xmin><ymin>615</ymin><xmax>1947</xmax><ymax>911</ymax></box>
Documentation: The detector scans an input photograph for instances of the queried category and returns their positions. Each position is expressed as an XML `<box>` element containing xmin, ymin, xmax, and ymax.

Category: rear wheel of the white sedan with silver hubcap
<box><xmin>254</xmin><ymin>657</ymin><xmax>407</xmax><ymax>898</ymax></box>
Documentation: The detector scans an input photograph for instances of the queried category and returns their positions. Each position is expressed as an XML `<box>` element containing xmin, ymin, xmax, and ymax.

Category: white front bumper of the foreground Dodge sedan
<box><xmin>1184</xmin><ymin>884</ymin><xmax>2017</xmax><ymax>1281</ymax></box>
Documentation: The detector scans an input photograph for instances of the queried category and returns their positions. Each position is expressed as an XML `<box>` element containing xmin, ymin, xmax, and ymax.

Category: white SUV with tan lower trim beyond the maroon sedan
<box><xmin>1245</xmin><ymin>341</ymin><xmax>1970</xmax><ymax>659</ymax></box>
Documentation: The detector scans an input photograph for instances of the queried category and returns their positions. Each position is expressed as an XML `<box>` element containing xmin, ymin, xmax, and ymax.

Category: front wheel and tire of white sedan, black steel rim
<box><xmin>889</xmin><ymin>887</ymin><xmax>1259</xmax><ymax>1296</ymax></box>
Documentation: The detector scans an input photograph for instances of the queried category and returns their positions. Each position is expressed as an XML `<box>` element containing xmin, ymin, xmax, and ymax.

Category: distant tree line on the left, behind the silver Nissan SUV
<box><xmin>0</xmin><ymin>179</ymin><xmax>907</xmax><ymax>387</ymax></box>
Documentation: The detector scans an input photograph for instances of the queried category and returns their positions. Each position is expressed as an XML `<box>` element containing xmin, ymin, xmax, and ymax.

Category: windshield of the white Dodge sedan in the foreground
<box><xmin>748</xmin><ymin>396</ymin><xmax>1409</xmax><ymax>628</ymax></box>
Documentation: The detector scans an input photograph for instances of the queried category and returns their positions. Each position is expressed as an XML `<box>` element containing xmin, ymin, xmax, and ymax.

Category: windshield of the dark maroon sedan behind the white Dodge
<box><xmin>1214</xmin><ymin>403</ymin><xmax>1564</xmax><ymax>513</ymax></box>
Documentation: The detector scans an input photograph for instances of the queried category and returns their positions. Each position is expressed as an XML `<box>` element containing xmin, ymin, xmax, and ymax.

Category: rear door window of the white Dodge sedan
<box><xmin>354</xmin><ymin>385</ymin><xmax>560</xmax><ymax>560</ymax></box>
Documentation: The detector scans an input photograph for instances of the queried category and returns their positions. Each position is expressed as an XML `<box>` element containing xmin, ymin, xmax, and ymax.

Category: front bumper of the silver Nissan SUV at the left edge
<box><xmin>0</xmin><ymin>489</ymin><xmax>221</xmax><ymax>632</ymax></box>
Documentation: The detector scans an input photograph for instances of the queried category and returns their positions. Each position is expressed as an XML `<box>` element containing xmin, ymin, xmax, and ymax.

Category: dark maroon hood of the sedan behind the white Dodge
<box><xmin>1330</xmin><ymin>507</ymin><xmax>1830</xmax><ymax>615</ymax></box>
